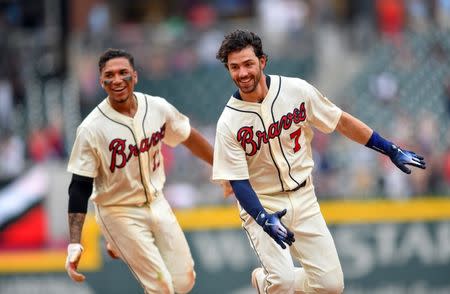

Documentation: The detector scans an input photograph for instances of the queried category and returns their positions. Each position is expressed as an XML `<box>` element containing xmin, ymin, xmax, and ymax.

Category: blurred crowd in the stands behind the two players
<box><xmin>0</xmin><ymin>0</ymin><xmax>450</xmax><ymax>206</ymax></box>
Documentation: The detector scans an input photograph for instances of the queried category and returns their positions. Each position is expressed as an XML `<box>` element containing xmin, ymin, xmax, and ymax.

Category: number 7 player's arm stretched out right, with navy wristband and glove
<box><xmin>336</xmin><ymin>112</ymin><xmax>426</xmax><ymax>174</ymax></box>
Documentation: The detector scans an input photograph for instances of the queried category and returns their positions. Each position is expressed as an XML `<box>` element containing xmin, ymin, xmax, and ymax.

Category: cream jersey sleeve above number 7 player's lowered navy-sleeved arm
<box><xmin>212</xmin><ymin>124</ymin><xmax>249</xmax><ymax>181</ymax></box>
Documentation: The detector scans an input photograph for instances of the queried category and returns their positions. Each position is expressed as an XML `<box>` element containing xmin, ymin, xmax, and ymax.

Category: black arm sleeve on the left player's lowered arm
<box><xmin>68</xmin><ymin>174</ymin><xmax>94</xmax><ymax>213</ymax></box>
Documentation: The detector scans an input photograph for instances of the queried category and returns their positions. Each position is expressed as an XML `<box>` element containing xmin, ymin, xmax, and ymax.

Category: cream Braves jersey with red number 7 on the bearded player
<box><xmin>212</xmin><ymin>75</ymin><xmax>342</xmax><ymax>194</ymax></box>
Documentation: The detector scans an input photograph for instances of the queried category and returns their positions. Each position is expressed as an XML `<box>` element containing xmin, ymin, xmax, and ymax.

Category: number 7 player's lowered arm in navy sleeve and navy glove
<box><xmin>230</xmin><ymin>180</ymin><xmax>295</xmax><ymax>249</ymax></box>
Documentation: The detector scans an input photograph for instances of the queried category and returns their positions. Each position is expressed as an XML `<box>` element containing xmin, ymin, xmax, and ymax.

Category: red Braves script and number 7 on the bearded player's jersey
<box><xmin>237</xmin><ymin>102</ymin><xmax>306</xmax><ymax>156</ymax></box>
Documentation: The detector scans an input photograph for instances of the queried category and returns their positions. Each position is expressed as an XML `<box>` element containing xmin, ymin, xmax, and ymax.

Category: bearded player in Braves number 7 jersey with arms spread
<box><xmin>213</xmin><ymin>30</ymin><xmax>425</xmax><ymax>294</ymax></box>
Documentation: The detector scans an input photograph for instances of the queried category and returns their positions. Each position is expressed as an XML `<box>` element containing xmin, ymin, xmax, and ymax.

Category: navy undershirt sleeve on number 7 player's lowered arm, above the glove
<box><xmin>230</xmin><ymin>180</ymin><xmax>265</xmax><ymax>219</ymax></box>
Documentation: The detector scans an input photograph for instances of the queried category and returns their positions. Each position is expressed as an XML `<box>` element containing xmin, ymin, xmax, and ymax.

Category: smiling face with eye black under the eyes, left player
<box><xmin>100</xmin><ymin>57</ymin><xmax>138</xmax><ymax>104</ymax></box>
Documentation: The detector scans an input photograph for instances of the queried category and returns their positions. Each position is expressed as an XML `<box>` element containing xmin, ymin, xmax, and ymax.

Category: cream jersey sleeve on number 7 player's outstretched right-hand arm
<box><xmin>306</xmin><ymin>84</ymin><xmax>342</xmax><ymax>133</ymax></box>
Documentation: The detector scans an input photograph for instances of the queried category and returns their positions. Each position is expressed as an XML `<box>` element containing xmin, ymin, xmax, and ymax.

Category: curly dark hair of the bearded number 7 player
<box><xmin>216</xmin><ymin>30</ymin><xmax>268</xmax><ymax>67</ymax></box>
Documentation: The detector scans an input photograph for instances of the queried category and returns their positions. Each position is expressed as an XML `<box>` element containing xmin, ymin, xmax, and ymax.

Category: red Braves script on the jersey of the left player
<box><xmin>109</xmin><ymin>124</ymin><xmax>166</xmax><ymax>172</ymax></box>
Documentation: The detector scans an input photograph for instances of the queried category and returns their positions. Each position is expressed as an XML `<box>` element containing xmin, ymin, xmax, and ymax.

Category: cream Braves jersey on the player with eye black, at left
<box><xmin>67</xmin><ymin>92</ymin><xmax>191</xmax><ymax>206</ymax></box>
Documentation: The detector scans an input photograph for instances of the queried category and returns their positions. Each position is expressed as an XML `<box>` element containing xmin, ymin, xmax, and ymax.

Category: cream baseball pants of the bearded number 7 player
<box><xmin>241</xmin><ymin>178</ymin><xmax>344</xmax><ymax>294</ymax></box>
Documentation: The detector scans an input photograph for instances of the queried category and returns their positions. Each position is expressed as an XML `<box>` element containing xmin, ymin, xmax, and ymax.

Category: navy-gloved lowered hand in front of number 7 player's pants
<box><xmin>256</xmin><ymin>209</ymin><xmax>295</xmax><ymax>249</ymax></box>
